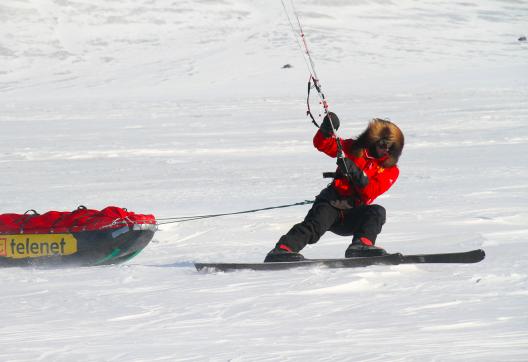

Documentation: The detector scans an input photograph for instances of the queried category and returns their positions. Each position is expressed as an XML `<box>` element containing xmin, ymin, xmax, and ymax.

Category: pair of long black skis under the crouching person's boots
<box><xmin>194</xmin><ymin>249</ymin><xmax>485</xmax><ymax>271</ymax></box>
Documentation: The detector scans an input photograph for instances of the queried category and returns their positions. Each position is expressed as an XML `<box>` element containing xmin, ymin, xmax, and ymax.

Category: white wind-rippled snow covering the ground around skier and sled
<box><xmin>0</xmin><ymin>0</ymin><xmax>528</xmax><ymax>361</ymax></box>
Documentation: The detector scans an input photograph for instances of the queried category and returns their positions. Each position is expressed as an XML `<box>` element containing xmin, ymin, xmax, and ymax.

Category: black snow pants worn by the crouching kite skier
<box><xmin>277</xmin><ymin>186</ymin><xmax>386</xmax><ymax>252</ymax></box>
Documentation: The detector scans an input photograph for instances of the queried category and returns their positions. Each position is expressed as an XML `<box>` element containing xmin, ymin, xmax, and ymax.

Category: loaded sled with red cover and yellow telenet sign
<box><xmin>0</xmin><ymin>206</ymin><xmax>157</xmax><ymax>267</ymax></box>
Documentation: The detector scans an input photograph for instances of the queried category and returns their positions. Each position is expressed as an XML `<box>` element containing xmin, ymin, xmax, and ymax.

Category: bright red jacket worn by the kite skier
<box><xmin>313</xmin><ymin>131</ymin><xmax>400</xmax><ymax>205</ymax></box>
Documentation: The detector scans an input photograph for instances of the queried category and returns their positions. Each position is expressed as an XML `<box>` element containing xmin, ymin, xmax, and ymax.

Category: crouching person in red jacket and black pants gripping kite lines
<box><xmin>264</xmin><ymin>112</ymin><xmax>404</xmax><ymax>262</ymax></box>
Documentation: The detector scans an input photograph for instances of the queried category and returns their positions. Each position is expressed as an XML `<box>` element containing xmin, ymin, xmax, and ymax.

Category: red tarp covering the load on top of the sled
<box><xmin>0</xmin><ymin>206</ymin><xmax>156</xmax><ymax>234</ymax></box>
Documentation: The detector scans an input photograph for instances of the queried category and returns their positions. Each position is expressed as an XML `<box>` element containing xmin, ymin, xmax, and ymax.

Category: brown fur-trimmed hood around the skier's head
<box><xmin>353</xmin><ymin>118</ymin><xmax>405</xmax><ymax>168</ymax></box>
